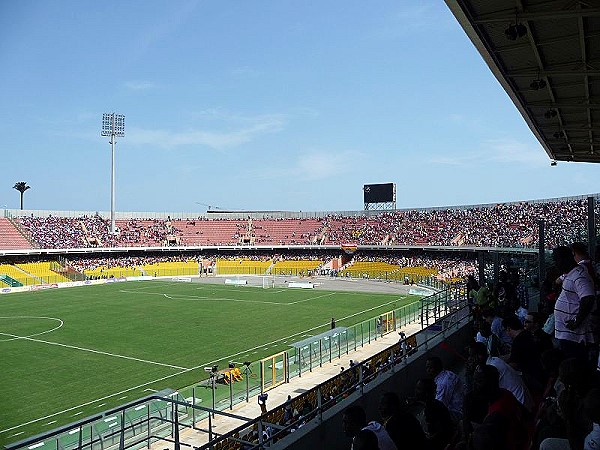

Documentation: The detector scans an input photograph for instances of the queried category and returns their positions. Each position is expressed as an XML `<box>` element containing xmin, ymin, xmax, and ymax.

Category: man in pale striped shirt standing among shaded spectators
<box><xmin>552</xmin><ymin>247</ymin><xmax>596</xmax><ymax>361</ymax></box>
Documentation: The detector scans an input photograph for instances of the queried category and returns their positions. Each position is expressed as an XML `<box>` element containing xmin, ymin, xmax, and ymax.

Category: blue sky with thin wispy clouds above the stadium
<box><xmin>0</xmin><ymin>0</ymin><xmax>598</xmax><ymax>212</ymax></box>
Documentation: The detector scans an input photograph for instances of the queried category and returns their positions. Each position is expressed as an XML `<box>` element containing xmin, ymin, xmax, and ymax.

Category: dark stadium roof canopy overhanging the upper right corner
<box><xmin>446</xmin><ymin>0</ymin><xmax>600</xmax><ymax>163</ymax></box>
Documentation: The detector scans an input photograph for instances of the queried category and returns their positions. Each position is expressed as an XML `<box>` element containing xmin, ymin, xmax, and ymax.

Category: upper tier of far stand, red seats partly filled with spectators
<box><xmin>8</xmin><ymin>194</ymin><xmax>587</xmax><ymax>249</ymax></box>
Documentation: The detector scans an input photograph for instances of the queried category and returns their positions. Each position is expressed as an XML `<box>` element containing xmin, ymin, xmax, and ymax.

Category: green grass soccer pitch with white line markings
<box><xmin>0</xmin><ymin>279</ymin><xmax>420</xmax><ymax>445</ymax></box>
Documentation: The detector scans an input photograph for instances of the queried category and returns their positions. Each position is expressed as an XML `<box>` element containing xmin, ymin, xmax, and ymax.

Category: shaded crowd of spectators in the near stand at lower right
<box><xmin>332</xmin><ymin>243</ymin><xmax>600</xmax><ymax>450</ymax></box>
